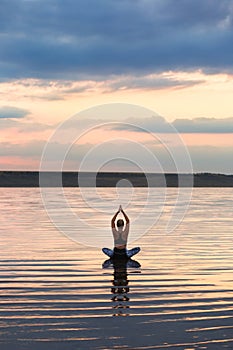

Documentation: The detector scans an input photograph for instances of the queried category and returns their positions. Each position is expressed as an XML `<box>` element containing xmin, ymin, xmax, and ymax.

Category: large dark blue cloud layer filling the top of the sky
<box><xmin>0</xmin><ymin>0</ymin><xmax>233</xmax><ymax>80</ymax></box>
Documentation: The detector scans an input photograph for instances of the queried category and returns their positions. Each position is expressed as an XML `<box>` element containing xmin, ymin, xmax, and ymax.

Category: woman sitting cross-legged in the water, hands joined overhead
<box><xmin>103</xmin><ymin>205</ymin><xmax>140</xmax><ymax>258</ymax></box>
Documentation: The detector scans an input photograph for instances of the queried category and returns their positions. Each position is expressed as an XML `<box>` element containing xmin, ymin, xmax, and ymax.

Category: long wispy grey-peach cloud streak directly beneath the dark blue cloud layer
<box><xmin>1</xmin><ymin>72</ymin><xmax>203</xmax><ymax>101</ymax></box>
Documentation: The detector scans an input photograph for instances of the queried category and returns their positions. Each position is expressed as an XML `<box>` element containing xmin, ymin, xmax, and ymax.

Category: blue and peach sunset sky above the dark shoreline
<box><xmin>0</xmin><ymin>0</ymin><xmax>233</xmax><ymax>174</ymax></box>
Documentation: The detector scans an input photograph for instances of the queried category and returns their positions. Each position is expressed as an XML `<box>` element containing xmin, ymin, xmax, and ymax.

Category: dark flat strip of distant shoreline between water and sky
<box><xmin>0</xmin><ymin>171</ymin><xmax>233</xmax><ymax>187</ymax></box>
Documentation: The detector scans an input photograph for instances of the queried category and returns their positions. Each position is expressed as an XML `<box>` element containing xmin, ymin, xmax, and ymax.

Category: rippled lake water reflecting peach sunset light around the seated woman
<box><xmin>0</xmin><ymin>188</ymin><xmax>233</xmax><ymax>350</ymax></box>
